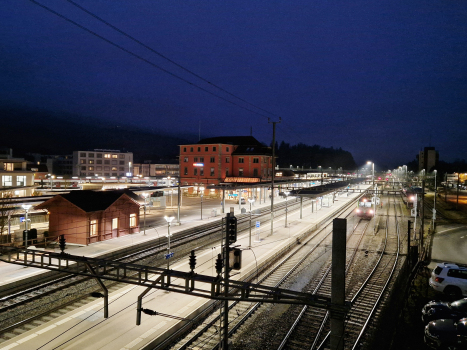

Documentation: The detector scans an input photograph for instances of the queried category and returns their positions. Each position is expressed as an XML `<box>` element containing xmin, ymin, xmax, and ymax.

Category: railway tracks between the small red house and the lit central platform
<box><xmin>0</xmin><ymin>196</ymin><xmax>344</xmax><ymax>342</ymax></box>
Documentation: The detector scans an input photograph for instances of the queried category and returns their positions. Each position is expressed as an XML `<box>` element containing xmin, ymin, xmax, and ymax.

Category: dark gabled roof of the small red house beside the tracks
<box><xmin>36</xmin><ymin>190</ymin><xmax>141</xmax><ymax>213</ymax></box>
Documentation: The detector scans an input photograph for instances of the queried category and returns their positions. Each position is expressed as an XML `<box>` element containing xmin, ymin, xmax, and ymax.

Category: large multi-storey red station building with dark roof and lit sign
<box><xmin>180</xmin><ymin>136</ymin><xmax>272</xmax><ymax>191</ymax></box>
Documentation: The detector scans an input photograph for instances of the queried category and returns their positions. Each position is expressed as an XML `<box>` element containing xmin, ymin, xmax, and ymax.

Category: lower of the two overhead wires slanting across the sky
<box><xmin>29</xmin><ymin>0</ymin><xmax>276</xmax><ymax>118</ymax></box>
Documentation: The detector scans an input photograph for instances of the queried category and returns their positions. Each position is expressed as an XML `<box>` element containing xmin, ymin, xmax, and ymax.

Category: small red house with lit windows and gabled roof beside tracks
<box><xmin>35</xmin><ymin>190</ymin><xmax>140</xmax><ymax>245</ymax></box>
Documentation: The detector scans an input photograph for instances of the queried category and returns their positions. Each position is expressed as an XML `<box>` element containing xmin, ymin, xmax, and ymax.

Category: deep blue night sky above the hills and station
<box><xmin>0</xmin><ymin>0</ymin><xmax>467</xmax><ymax>167</ymax></box>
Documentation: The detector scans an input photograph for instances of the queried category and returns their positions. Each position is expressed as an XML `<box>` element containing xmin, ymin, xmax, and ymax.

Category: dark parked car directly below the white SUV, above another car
<box><xmin>422</xmin><ymin>298</ymin><xmax>467</xmax><ymax>323</ymax></box>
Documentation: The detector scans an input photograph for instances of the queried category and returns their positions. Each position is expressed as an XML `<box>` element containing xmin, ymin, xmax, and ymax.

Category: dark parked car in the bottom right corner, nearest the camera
<box><xmin>424</xmin><ymin>318</ymin><xmax>467</xmax><ymax>350</ymax></box>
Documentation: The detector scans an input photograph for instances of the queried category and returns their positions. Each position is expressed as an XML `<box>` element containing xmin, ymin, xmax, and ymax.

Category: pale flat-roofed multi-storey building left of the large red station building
<box><xmin>73</xmin><ymin>149</ymin><xmax>133</xmax><ymax>177</ymax></box>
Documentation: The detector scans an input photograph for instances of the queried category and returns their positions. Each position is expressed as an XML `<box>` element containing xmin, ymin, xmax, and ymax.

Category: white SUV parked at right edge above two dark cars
<box><xmin>429</xmin><ymin>263</ymin><xmax>467</xmax><ymax>299</ymax></box>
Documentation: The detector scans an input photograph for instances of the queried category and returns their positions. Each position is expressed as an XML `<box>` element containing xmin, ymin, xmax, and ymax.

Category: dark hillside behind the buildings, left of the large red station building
<box><xmin>0</xmin><ymin>107</ymin><xmax>196</xmax><ymax>162</ymax></box>
